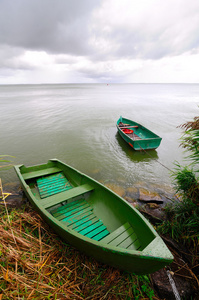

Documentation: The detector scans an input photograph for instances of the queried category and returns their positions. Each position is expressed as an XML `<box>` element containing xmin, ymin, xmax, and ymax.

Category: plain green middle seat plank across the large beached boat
<box><xmin>41</xmin><ymin>184</ymin><xmax>94</xmax><ymax>208</ymax></box>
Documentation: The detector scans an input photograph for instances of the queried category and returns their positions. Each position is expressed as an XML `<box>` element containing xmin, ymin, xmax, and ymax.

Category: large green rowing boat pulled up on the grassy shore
<box><xmin>15</xmin><ymin>159</ymin><xmax>173</xmax><ymax>274</ymax></box>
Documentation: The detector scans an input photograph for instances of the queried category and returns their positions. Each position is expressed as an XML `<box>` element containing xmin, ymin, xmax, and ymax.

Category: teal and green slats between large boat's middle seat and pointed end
<box><xmin>51</xmin><ymin>199</ymin><xmax>141</xmax><ymax>250</ymax></box>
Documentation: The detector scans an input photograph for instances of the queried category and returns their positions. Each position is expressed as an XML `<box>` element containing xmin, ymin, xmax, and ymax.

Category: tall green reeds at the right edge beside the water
<box><xmin>157</xmin><ymin>117</ymin><xmax>199</xmax><ymax>264</ymax></box>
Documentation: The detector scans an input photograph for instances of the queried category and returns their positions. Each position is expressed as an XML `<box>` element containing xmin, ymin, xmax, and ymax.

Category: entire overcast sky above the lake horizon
<box><xmin>0</xmin><ymin>0</ymin><xmax>199</xmax><ymax>84</ymax></box>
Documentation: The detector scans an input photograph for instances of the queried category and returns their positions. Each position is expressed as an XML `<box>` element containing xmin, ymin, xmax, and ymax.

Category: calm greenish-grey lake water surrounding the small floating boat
<box><xmin>0</xmin><ymin>84</ymin><xmax>199</xmax><ymax>188</ymax></box>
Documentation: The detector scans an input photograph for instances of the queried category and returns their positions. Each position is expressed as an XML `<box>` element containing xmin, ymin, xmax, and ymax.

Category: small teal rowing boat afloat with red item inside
<box><xmin>116</xmin><ymin>117</ymin><xmax>162</xmax><ymax>150</ymax></box>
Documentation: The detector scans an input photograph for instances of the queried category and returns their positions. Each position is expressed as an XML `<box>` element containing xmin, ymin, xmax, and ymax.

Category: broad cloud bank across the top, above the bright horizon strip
<box><xmin>0</xmin><ymin>0</ymin><xmax>199</xmax><ymax>59</ymax></box>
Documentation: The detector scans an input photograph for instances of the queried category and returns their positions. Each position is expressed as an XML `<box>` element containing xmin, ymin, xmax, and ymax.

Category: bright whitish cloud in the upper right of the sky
<box><xmin>89</xmin><ymin>0</ymin><xmax>199</xmax><ymax>59</ymax></box>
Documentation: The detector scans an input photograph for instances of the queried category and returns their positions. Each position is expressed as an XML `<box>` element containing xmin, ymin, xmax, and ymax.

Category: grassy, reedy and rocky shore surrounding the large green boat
<box><xmin>0</xmin><ymin>117</ymin><xmax>199</xmax><ymax>300</ymax></box>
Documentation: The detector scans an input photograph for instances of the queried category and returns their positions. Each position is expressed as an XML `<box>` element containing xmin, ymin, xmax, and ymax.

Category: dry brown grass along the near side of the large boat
<box><xmin>0</xmin><ymin>205</ymin><xmax>157</xmax><ymax>300</ymax></box>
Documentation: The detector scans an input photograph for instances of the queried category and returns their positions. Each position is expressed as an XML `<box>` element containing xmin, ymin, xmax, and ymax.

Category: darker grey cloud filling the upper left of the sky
<box><xmin>0</xmin><ymin>0</ymin><xmax>99</xmax><ymax>55</ymax></box>
